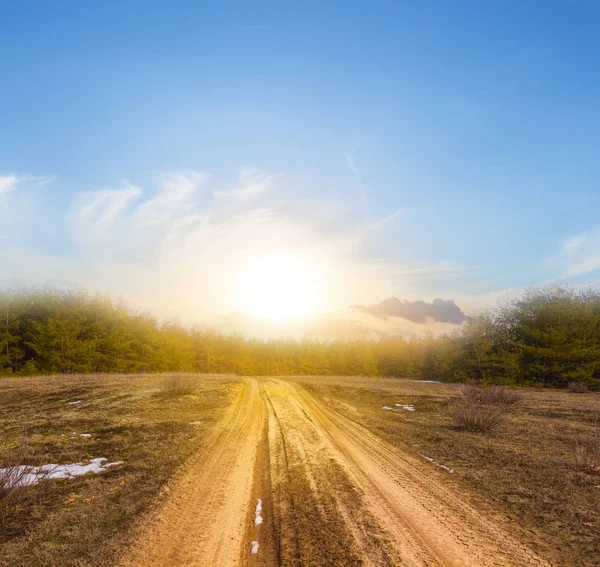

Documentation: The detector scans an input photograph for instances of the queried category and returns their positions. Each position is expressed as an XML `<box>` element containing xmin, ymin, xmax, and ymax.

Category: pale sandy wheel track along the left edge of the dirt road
<box><xmin>121</xmin><ymin>380</ymin><xmax>264</xmax><ymax>567</ymax></box>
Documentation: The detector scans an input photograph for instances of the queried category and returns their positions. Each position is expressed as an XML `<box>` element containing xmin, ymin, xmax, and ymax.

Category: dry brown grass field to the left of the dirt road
<box><xmin>0</xmin><ymin>376</ymin><xmax>238</xmax><ymax>567</ymax></box>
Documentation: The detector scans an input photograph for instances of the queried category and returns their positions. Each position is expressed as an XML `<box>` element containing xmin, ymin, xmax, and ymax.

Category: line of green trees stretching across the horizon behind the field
<box><xmin>0</xmin><ymin>287</ymin><xmax>600</xmax><ymax>389</ymax></box>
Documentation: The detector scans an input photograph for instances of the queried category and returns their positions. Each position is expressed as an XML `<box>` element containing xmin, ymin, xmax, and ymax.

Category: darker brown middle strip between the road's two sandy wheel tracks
<box><xmin>264</xmin><ymin>380</ymin><xmax>401</xmax><ymax>567</ymax></box>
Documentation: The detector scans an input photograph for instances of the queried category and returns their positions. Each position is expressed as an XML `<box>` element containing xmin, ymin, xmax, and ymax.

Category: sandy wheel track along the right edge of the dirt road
<box><xmin>280</xmin><ymin>381</ymin><xmax>550</xmax><ymax>567</ymax></box>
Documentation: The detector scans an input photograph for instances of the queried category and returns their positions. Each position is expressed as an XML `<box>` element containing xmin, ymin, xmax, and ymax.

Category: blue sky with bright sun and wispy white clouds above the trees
<box><xmin>0</xmin><ymin>0</ymin><xmax>600</xmax><ymax>336</ymax></box>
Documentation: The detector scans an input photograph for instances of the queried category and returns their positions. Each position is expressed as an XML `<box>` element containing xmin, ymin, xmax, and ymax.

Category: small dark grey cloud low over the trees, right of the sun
<box><xmin>355</xmin><ymin>297</ymin><xmax>469</xmax><ymax>325</ymax></box>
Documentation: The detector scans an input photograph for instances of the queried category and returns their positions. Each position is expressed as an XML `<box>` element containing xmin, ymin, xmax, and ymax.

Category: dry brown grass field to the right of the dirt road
<box><xmin>297</xmin><ymin>376</ymin><xmax>600</xmax><ymax>567</ymax></box>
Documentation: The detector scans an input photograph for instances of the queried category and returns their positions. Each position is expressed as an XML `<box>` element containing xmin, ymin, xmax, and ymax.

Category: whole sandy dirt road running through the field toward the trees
<box><xmin>122</xmin><ymin>379</ymin><xmax>550</xmax><ymax>567</ymax></box>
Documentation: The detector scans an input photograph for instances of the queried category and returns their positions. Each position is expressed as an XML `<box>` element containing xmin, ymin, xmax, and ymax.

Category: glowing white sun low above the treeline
<box><xmin>239</xmin><ymin>251</ymin><xmax>322</xmax><ymax>321</ymax></box>
